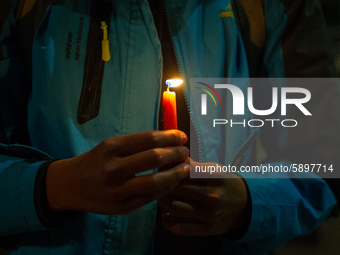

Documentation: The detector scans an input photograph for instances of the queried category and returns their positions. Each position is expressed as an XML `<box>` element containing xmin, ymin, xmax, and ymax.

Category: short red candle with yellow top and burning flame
<box><xmin>163</xmin><ymin>79</ymin><xmax>183</xmax><ymax>130</ymax></box>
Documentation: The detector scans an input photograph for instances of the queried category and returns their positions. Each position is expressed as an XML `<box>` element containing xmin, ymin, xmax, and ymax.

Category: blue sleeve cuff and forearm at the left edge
<box><xmin>0</xmin><ymin>151</ymin><xmax>46</xmax><ymax>236</ymax></box>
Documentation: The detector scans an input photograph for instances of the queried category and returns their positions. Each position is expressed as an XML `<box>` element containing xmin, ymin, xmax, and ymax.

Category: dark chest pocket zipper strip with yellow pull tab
<box><xmin>77</xmin><ymin>0</ymin><xmax>112</xmax><ymax>125</ymax></box>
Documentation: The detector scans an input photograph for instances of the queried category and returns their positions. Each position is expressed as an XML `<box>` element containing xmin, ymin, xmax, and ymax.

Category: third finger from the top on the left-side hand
<box><xmin>121</xmin><ymin>163</ymin><xmax>190</xmax><ymax>196</ymax></box>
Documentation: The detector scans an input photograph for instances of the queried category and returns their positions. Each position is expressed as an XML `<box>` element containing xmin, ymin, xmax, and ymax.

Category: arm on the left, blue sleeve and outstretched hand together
<box><xmin>0</xmin><ymin>131</ymin><xmax>190</xmax><ymax>235</ymax></box>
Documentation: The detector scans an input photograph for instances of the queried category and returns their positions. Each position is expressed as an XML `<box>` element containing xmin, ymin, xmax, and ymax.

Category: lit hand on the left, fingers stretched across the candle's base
<box><xmin>46</xmin><ymin>130</ymin><xmax>190</xmax><ymax>215</ymax></box>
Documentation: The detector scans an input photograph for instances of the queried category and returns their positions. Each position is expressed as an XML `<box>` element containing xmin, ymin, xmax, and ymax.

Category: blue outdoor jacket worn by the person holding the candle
<box><xmin>0</xmin><ymin>0</ymin><xmax>336</xmax><ymax>255</ymax></box>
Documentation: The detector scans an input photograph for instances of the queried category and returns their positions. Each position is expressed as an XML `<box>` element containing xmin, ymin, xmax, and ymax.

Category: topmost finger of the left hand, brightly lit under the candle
<box><xmin>107</xmin><ymin>130</ymin><xmax>188</xmax><ymax>156</ymax></box>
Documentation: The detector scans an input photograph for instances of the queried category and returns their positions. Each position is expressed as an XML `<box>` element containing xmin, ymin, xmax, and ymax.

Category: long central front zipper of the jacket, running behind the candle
<box><xmin>164</xmin><ymin>0</ymin><xmax>202</xmax><ymax>161</ymax></box>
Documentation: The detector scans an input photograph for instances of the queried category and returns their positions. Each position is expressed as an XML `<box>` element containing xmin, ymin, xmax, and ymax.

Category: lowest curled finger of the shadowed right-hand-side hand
<box><xmin>162</xmin><ymin>213</ymin><xmax>210</xmax><ymax>236</ymax></box>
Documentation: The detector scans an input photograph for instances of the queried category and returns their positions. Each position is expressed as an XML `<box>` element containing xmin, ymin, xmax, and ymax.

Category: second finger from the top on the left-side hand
<box><xmin>112</xmin><ymin>146</ymin><xmax>189</xmax><ymax>176</ymax></box>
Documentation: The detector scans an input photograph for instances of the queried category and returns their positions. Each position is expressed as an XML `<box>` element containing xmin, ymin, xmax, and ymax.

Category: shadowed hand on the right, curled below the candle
<box><xmin>158</xmin><ymin>160</ymin><xmax>249</xmax><ymax>236</ymax></box>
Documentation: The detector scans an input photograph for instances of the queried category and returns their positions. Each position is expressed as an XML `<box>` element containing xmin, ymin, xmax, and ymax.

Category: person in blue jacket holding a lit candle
<box><xmin>0</xmin><ymin>0</ymin><xmax>340</xmax><ymax>255</ymax></box>
